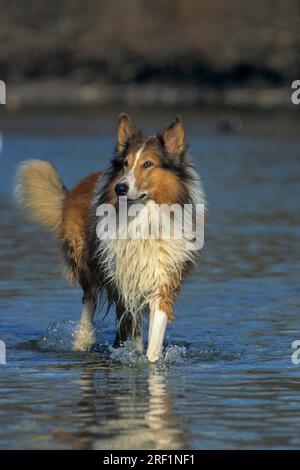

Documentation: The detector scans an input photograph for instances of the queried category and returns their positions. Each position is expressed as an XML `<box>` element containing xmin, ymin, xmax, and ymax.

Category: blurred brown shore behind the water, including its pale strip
<box><xmin>0</xmin><ymin>0</ymin><xmax>300</xmax><ymax>110</ymax></box>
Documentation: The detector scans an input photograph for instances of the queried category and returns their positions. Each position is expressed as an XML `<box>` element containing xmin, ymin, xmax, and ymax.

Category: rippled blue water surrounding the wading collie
<box><xmin>0</xmin><ymin>111</ymin><xmax>300</xmax><ymax>449</ymax></box>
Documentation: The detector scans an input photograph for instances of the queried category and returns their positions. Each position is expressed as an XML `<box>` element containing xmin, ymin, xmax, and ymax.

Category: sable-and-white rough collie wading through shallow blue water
<box><xmin>15</xmin><ymin>114</ymin><xmax>204</xmax><ymax>362</ymax></box>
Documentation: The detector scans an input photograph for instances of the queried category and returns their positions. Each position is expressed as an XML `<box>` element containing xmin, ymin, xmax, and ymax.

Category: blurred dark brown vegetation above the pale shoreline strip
<box><xmin>0</xmin><ymin>0</ymin><xmax>300</xmax><ymax>88</ymax></box>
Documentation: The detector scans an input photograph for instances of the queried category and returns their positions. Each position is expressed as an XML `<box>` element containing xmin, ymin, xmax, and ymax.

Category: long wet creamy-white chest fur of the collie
<box><xmin>97</xmin><ymin>203</ymin><xmax>194</xmax><ymax>315</ymax></box>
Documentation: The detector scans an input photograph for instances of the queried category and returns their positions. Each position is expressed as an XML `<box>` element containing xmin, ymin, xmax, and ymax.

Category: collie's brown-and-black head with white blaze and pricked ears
<box><xmin>111</xmin><ymin>114</ymin><xmax>188</xmax><ymax>204</ymax></box>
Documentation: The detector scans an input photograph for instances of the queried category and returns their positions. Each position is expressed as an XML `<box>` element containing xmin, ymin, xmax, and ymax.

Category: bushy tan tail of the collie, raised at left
<box><xmin>14</xmin><ymin>160</ymin><xmax>67</xmax><ymax>235</ymax></box>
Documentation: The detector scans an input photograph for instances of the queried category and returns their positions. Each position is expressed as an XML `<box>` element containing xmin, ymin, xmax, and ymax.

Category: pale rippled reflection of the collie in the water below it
<box><xmin>78</xmin><ymin>366</ymin><xmax>186</xmax><ymax>450</ymax></box>
